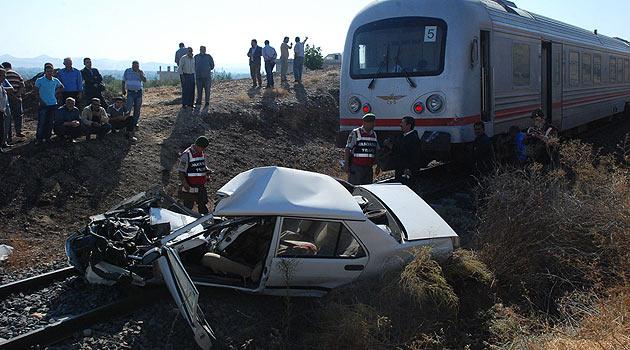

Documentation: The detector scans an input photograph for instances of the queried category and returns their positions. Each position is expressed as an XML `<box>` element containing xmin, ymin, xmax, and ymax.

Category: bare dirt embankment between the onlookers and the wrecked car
<box><xmin>0</xmin><ymin>70</ymin><xmax>341</xmax><ymax>271</ymax></box>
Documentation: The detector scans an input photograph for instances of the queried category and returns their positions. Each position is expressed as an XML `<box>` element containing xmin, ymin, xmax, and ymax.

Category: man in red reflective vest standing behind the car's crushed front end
<box><xmin>177</xmin><ymin>136</ymin><xmax>210</xmax><ymax>215</ymax></box>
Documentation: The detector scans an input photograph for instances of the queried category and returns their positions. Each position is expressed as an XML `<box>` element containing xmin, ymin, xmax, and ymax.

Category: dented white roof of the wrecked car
<box><xmin>213</xmin><ymin>166</ymin><xmax>366</xmax><ymax>221</ymax></box>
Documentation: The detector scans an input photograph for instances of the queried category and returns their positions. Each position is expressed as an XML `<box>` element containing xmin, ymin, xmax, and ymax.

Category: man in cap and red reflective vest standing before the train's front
<box><xmin>344</xmin><ymin>113</ymin><xmax>380</xmax><ymax>185</ymax></box>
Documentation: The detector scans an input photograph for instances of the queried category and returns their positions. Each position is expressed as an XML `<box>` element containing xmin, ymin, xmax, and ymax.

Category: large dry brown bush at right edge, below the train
<box><xmin>478</xmin><ymin>141</ymin><xmax>630</xmax><ymax>312</ymax></box>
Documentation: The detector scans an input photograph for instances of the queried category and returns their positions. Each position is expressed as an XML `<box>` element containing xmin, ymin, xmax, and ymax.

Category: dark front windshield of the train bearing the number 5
<box><xmin>350</xmin><ymin>17</ymin><xmax>446</xmax><ymax>79</ymax></box>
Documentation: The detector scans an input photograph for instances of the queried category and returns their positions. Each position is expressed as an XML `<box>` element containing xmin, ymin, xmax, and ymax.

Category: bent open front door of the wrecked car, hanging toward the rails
<box><xmin>158</xmin><ymin>247</ymin><xmax>216</xmax><ymax>349</ymax></box>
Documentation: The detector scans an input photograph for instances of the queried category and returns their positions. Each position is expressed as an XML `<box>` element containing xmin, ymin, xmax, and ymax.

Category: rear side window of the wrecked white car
<box><xmin>277</xmin><ymin>219</ymin><xmax>365</xmax><ymax>258</ymax></box>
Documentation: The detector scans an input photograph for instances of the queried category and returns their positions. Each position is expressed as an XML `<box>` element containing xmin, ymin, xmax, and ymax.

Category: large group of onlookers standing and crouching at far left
<box><xmin>0</xmin><ymin>57</ymin><xmax>152</xmax><ymax>152</ymax></box>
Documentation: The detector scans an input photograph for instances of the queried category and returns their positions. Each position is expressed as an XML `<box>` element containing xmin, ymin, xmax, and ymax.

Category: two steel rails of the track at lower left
<box><xmin>0</xmin><ymin>267</ymin><xmax>168</xmax><ymax>350</ymax></box>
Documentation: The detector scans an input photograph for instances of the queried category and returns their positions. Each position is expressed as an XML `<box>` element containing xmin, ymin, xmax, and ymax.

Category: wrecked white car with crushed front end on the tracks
<box><xmin>66</xmin><ymin>167</ymin><xmax>458</xmax><ymax>348</ymax></box>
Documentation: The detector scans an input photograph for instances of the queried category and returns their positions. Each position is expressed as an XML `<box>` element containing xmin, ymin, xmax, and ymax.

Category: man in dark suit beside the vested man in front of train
<box><xmin>384</xmin><ymin>116</ymin><xmax>421</xmax><ymax>189</ymax></box>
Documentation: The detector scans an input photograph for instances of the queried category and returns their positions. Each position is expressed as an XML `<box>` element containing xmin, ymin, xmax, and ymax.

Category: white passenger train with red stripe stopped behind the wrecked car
<box><xmin>338</xmin><ymin>0</ymin><xmax>630</xmax><ymax>157</ymax></box>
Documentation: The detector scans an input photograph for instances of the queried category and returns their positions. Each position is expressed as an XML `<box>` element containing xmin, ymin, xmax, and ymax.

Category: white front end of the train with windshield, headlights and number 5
<box><xmin>338</xmin><ymin>0</ymin><xmax>491</xmax><ymax>159</ymax></box>
